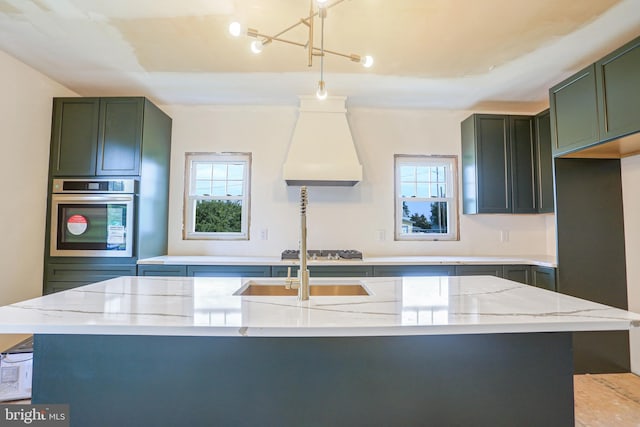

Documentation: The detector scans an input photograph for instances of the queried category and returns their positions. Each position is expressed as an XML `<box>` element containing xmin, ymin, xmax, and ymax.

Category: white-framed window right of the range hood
<box><xmin>395</xmin><ymin>155</ymin><xmax>458</xmax><ymax>240</ymax></box>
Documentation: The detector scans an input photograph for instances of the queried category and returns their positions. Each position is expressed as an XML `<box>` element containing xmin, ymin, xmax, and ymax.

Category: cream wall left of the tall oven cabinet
<box><xmin>0</xmin><ymin>51</ymin><xmax>76</xmax><ymax>349</ymax></box>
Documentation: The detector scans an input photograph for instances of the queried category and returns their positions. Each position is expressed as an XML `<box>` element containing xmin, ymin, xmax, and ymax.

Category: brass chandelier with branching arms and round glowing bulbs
<box><xmin>229</xmin><ymin>0</ymin><xmax>373</xmax><ymax>99</ymax></box>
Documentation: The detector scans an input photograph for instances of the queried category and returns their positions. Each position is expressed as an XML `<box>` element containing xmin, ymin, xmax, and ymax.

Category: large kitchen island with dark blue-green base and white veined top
<box><xmin>0</xmin><ymin>276</ymin><xmax>640</xmax><ymax>426</ymax></box>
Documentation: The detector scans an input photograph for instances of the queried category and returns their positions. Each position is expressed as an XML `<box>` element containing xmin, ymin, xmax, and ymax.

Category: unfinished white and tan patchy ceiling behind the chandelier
<box><xmin>0</xmin><ymin>0</ymin><xmax>640</xmax><ymax>109</ymax></box>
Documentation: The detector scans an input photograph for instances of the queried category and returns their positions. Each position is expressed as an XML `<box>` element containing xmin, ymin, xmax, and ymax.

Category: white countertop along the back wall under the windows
<box><xmin>138</xmin><ymin>255</ymin><xmax>557</xmax><ymax>267</ymax></box>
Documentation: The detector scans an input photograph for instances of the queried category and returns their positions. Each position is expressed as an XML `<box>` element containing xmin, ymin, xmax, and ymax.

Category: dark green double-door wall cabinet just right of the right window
<box><xmin>462</xmin><ymin>114</ymin><xmax>537</xmax><ymax>214</ymax></box>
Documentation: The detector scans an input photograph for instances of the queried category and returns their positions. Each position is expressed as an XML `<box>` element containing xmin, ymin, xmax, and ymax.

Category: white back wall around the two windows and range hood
<box><xmin>163</xmin><ymin>105</ymin><xmax>555</xmax><ymax>256</ymax></box>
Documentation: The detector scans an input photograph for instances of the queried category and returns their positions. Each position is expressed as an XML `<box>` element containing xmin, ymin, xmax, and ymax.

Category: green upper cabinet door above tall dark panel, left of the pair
<box><xmin>549</xmin><ymin>65</ymin><xmax>600</xmax><ymax>156</ymax></box>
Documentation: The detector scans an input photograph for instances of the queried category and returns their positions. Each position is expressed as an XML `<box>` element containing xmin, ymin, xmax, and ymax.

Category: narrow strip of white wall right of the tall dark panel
<box><xmin>622</xmin><ymin>155</ymin><xmax>640</xmax><ymax>375</ymax></box>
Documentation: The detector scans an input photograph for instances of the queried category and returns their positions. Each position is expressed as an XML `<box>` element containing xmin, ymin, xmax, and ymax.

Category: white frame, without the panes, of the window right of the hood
<box><xmin>393</xmin><ymin>154</ymin><xmax>460</xmax><ymax>241</ymax></box>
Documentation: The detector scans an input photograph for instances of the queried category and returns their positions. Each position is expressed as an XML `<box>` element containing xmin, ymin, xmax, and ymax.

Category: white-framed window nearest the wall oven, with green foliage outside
<box><xmin>184</xmin><ymin>153</ymin><xmax>251</xmax><ymax>240</ymax></box>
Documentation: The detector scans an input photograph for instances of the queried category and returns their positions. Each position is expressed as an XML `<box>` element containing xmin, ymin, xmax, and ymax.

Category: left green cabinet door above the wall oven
<box><xmin>50</xmin><ymin>98</ymin><xmax>100</xmax><ymax>177</ymax></box>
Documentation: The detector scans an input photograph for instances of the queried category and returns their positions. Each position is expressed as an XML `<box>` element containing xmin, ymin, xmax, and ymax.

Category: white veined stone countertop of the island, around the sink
<box><xmin>0</xmin><ymin>276</ymin><xmax>640</xmax><ymax>337</ymax></box>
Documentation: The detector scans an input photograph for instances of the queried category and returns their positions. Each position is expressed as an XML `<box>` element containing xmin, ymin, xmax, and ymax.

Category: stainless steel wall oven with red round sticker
<box><xmin>50</xmin><ymin>179</ymin><xmax>136</xmax><ymax>257</ymax></box>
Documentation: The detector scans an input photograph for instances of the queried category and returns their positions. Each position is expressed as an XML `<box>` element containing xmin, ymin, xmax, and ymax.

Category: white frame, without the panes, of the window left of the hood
<box><xmin>182</xmin><ymin>153</ymin><xmax>251</xmax><ymax>240</ymax></box>
